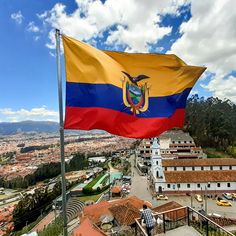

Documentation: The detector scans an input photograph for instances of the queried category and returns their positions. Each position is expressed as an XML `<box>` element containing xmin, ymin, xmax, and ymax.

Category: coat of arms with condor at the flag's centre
<box><xmin>122</xmin><ymin>71</ymin><xmax>149</xmax><ymax>115</ymax></box>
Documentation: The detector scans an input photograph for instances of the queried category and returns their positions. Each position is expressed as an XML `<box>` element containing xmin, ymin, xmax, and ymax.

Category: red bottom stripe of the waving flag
<box><xmin>64</xmin><ymin>107</ymin><xmax>185</xmax><ymax>138</ymax></box>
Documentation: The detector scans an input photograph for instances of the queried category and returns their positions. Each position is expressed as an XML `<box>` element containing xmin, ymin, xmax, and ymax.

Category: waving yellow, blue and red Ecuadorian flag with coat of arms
<box><xmin>63</xmin><ymin>36</ymin><xmax>205</xmax><ymax>138</ymax></box>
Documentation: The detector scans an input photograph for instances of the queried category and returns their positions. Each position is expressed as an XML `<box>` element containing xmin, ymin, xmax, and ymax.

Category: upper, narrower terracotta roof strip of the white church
<box><xmin>162</xmin><ymin>158</ymin><xmax>236</xmax><ymax>167</ymax></box>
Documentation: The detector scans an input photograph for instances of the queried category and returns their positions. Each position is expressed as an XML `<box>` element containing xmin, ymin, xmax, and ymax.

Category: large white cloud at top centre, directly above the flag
<box><xmin>37</xmin><ymin>0</ymin><xmax>187</xmax><ymax>52</ymax></box>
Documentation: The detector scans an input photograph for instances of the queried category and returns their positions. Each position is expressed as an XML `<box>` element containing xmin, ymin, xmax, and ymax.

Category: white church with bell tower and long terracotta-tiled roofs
<box><xmin>150</xmin><ymin>139</ymin><xmax>236</xmax><ymax>194</ymax></box>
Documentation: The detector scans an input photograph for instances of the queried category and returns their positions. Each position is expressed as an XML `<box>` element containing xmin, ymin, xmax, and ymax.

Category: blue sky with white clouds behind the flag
<box><xmin>0</xmin><ymin>0</ymin><xmax>236</xmax><ymax>122</ymax></box>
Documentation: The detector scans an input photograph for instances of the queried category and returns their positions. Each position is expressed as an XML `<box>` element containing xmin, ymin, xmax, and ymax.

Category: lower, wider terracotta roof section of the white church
<box><xmin>164</xmin><ymin>170</ymin><xmax>236</xmax><ymax>183</ymax></box>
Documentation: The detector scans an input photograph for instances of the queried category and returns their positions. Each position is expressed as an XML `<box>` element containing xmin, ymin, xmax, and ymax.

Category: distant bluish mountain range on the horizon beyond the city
<box><xmin>0</xmin><ymin>120</ymin><xmax>104</xmax><ymax>135</ymax></box>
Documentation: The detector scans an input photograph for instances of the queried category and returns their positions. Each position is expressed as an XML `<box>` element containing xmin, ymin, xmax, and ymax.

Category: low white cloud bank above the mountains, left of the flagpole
<box><xmin>0</xmin><ymin>106</ymin><xmax>58</xmax><ymax>122</ymax></box>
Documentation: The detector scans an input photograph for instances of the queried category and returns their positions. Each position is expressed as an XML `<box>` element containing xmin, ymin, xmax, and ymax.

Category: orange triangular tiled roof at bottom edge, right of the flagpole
<box><xmin>72</xmin><ymin>218</ymin><xmax>106</xmax><ymax>236</ymax></box>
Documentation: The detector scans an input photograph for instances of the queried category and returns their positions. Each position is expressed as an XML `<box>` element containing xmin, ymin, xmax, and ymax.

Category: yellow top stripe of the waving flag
<box><xmin>63</xmin><ymin>36</ymin><xmax>206</xmax><ymax>97</ymax></box>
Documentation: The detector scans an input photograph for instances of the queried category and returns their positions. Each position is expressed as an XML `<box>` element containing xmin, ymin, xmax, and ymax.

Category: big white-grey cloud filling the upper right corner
<box><xmin>170</xmin><ymin>0</ymin><xmax>236</xmax><ymax>102</ymax></box>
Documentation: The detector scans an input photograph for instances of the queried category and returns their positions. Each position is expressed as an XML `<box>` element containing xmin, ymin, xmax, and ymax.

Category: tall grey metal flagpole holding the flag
<box><xmin>55</xmin><ymin>29</ymin><xmax>68</xmax><ymax>236</ymax></box>
